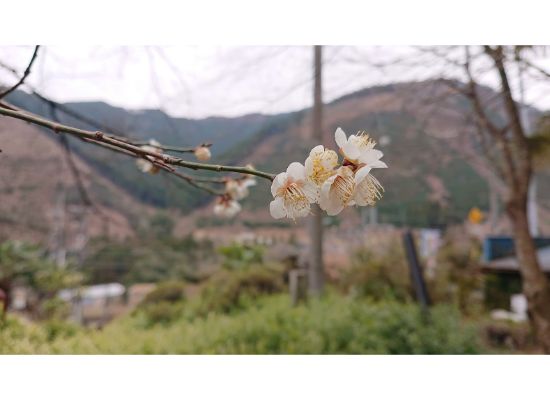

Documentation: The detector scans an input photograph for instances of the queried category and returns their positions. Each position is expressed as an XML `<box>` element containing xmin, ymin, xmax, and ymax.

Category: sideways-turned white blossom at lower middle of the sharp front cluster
<box><xmin>319</xmin><ymin>166</ymin><xmax>356</xmax><ymax>215</ymax></box>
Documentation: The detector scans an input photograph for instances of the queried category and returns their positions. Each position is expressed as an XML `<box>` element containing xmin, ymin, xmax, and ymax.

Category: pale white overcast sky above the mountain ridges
<box><xmin>0</xmin><ymin>46</ymin><xmax>550</xmax><ymax>118</ymax></box>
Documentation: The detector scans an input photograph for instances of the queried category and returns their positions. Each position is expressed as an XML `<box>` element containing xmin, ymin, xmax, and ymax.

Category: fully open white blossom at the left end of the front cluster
<box><xmin>269</xmin><ymin>162</ymin><xmax>317</xmax><ymax>219</ymax></box>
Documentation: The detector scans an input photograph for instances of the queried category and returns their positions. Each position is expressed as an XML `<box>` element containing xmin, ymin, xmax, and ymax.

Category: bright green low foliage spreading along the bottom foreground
<box><xmin>9</xmin><ymin>295</ymin><xmax>485</xmax><ymax>354</ymax></box>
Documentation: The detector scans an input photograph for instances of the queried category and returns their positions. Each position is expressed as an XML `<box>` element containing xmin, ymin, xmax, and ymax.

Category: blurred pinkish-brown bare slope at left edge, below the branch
<box><xmin>0</xmin><ymin>118</ymin><xmax>153</xmax><ymax>244</ymax></box>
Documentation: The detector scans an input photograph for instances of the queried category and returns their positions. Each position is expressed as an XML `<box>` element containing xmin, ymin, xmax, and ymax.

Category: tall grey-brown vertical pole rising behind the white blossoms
<box><xmin>309</xmin><ymin>46</ymin><xmax>324</xmax><ymax>296</ymax></box>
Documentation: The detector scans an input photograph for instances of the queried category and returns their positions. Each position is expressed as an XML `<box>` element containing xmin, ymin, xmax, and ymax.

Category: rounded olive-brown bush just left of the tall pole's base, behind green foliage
<box><xmin>198</xmin><ymin>267</ymin><xmax>285</xmax><ymax>315</ymax></box>
